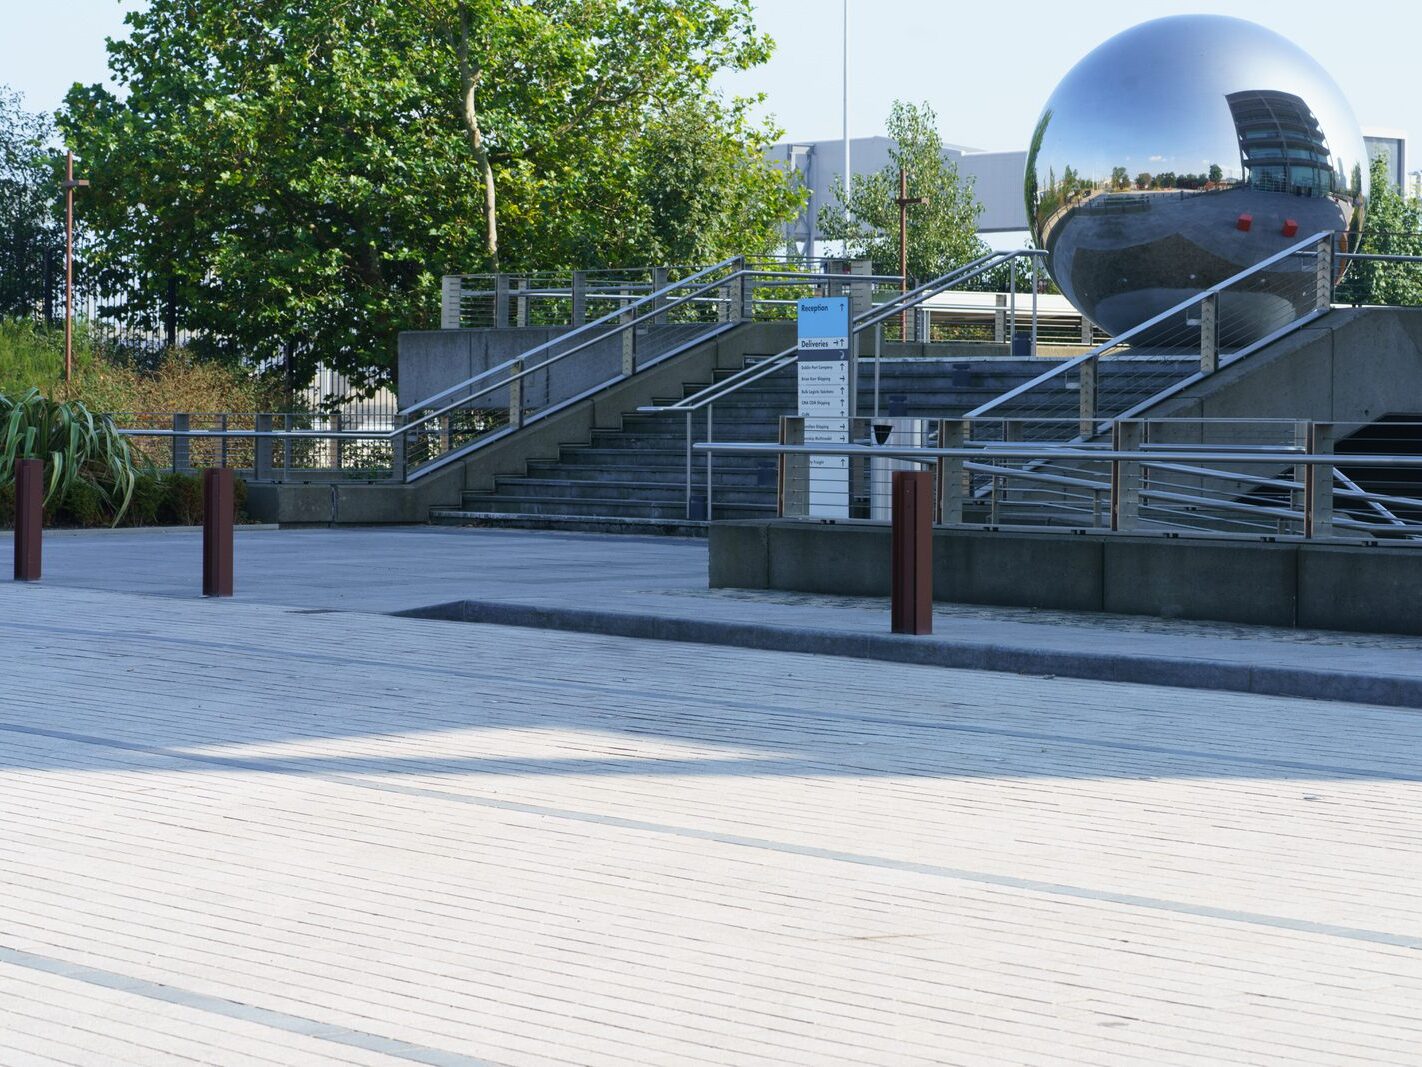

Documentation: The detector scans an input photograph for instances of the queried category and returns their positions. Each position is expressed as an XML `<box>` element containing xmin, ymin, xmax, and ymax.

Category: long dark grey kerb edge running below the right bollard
<box><xmin>394</xmin><ymin>600</ymin><xmax>1422</xmax><ymax>708</ymax></box>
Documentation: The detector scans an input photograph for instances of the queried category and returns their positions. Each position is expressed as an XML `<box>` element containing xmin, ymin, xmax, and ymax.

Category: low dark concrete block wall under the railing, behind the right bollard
<box><xmin>710</xmin><ymin>521</ymin><xmax>1422</xmax><ymax>635</ymax></box>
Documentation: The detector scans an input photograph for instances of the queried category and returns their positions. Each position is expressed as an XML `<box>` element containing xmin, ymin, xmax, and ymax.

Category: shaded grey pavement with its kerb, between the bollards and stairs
<box><xmin>8</xmin><ymin>528</ymin><xmax>1422</xmax><ymax>707</ymax></box>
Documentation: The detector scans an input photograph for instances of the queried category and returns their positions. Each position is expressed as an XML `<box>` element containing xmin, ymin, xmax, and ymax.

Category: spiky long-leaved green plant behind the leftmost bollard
<box><xmin>0</xmin><ymin>388</ymin><xmax>138</xmax><ymax>526</ymax></box>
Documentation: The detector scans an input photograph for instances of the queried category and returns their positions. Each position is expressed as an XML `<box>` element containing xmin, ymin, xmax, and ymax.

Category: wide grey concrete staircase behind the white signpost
<box><xmin>431</xmin><ymin>356</ymin><xmax>1069</xmax><ymax>535</ymax></box>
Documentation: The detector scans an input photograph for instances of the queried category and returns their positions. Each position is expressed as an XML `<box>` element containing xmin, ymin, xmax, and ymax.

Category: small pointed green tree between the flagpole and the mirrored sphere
<box><xmin>819</xmin><ymin>101</ymin><xmax>985</xmax><ymax>279</ymax></box>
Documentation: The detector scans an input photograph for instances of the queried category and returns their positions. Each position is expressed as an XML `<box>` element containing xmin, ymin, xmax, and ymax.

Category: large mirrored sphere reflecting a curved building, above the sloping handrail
<box><xmin>1025</xmin><ymin>16</ymin><xmax>1368</xmax><ymax>342</ymax></box>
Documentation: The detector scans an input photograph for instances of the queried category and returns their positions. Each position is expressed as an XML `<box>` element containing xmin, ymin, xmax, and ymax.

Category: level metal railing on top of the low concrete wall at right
<box><xmin>695</xmin><ymin>420</ymin><xmax>1422</xmax><ymax>546</ymax></box>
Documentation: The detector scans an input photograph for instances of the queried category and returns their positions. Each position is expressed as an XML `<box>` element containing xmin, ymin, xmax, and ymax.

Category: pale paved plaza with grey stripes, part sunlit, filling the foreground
<box><xmin>0</xmin><ymin>531</ymin><xmax>1422</xmax><ymax>1067</ymax></box>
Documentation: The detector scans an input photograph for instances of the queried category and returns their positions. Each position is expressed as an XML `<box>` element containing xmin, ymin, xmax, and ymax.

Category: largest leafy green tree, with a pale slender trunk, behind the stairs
<box><xmin>60</xmin><ymin>0</ymin><xmax>799</xmax><ymax>383</ymax></box>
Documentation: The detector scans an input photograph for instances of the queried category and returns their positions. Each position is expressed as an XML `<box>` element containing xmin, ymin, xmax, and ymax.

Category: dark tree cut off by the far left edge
<box><xmin>0</xmin><ymin>85</ymin><xmax>64</xmax><ymax>316</ymax></box>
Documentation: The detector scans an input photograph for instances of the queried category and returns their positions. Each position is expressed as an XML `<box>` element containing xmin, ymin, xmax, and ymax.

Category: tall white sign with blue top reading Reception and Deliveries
<box><xmin>796</xmin><ymin>296</ymin><xmax>853</xmax><ymax>519</ymax></box>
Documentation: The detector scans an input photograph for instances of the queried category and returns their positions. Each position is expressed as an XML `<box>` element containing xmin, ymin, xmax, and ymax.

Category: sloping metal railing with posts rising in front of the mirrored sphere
<box><xmin>968</xmin><ymin>232</ymin><xmax>1335</xmax><ymax>440</ymax></box>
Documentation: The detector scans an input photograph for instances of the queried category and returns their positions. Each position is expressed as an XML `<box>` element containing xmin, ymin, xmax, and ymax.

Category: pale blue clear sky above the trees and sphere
<box><xmin>8</xmin><ymin>0</ymin><xmax>1422</xmax><ymax>162</ymax></box>
